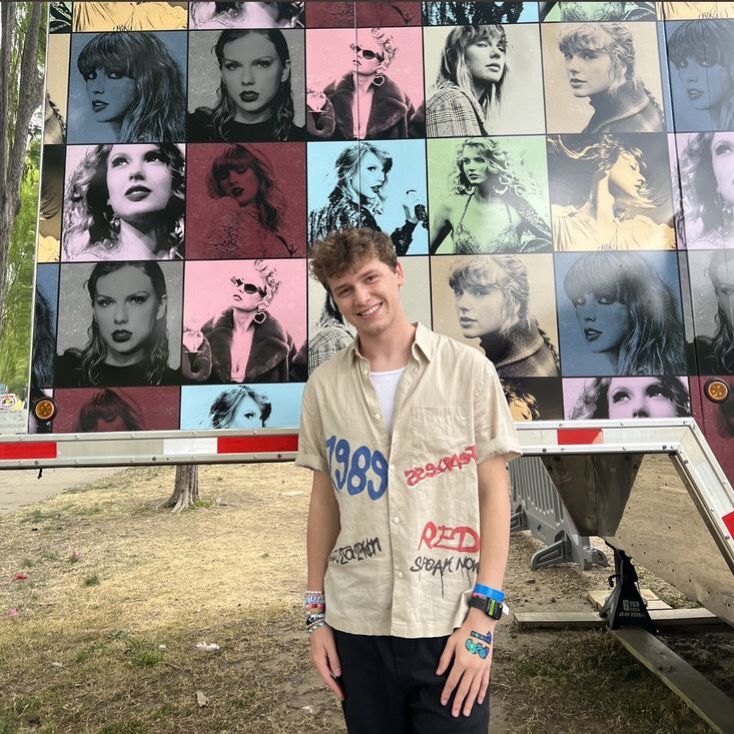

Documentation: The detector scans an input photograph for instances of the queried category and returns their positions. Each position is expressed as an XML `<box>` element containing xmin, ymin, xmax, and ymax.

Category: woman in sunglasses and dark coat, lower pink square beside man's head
<box><xmin>182</xmin><ymin>260</ymin><xmax>306</xmax><ymax>384</ymax></box>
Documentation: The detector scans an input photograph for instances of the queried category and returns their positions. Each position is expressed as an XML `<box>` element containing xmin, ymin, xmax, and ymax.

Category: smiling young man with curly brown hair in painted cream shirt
<box><xmin>296</xmin><ymin>228</ymin><xmax>520</xmax><ymax>734</ymax></box>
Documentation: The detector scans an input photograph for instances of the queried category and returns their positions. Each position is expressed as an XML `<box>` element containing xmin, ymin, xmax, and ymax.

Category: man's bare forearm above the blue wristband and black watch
<box><xmin>477</xmin><ymin>456</ymin><xmax>510</xmax><ymax>590</ymax></box>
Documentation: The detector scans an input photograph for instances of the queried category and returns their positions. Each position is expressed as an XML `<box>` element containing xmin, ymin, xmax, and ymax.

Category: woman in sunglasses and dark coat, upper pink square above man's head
<box><xmin>306</xmin><ymin>28</ymin><xmax>425</xmax><ymax>140</ymax></box>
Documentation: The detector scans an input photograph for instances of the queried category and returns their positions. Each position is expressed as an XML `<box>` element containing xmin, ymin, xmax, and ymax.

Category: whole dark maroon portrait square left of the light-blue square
<box><xmin>186</xmin><ymin>143</ymin><xmax>306</xmax><ymax>260</ymax></box>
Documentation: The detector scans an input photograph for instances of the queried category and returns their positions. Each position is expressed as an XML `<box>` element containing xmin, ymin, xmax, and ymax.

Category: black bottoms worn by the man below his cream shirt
<box><xmin>334</xmin><ymin>630</ymin><xmax>489</xmax><ymax>734</ymax></box>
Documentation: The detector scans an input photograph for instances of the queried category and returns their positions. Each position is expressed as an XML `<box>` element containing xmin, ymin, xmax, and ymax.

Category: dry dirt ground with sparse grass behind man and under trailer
<box><xmin>0</xmin><ymin>464</ymin><xmax>734</xmax><ymax>734</ymax></box>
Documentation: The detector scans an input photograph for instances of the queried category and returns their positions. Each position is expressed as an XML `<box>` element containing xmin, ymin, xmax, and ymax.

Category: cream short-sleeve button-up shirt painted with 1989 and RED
<box><xmin>296</xmin><ymin>324</ymin><xmax>521</xmax><ymax>637</ymax></box>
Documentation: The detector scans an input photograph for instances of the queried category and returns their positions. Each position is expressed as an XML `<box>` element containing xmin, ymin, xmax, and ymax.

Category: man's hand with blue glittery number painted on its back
<box><xmin>436</xmin><ymin>609</ymin><xmax>497</xmax><ymax>716</ymax></box>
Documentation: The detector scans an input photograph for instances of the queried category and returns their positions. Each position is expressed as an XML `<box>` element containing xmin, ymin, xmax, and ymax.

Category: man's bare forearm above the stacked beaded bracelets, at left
<box><xmin>306</xmin><ymin>472</ymin><xmax>340</xmax><ymax>591</ymax></box>
